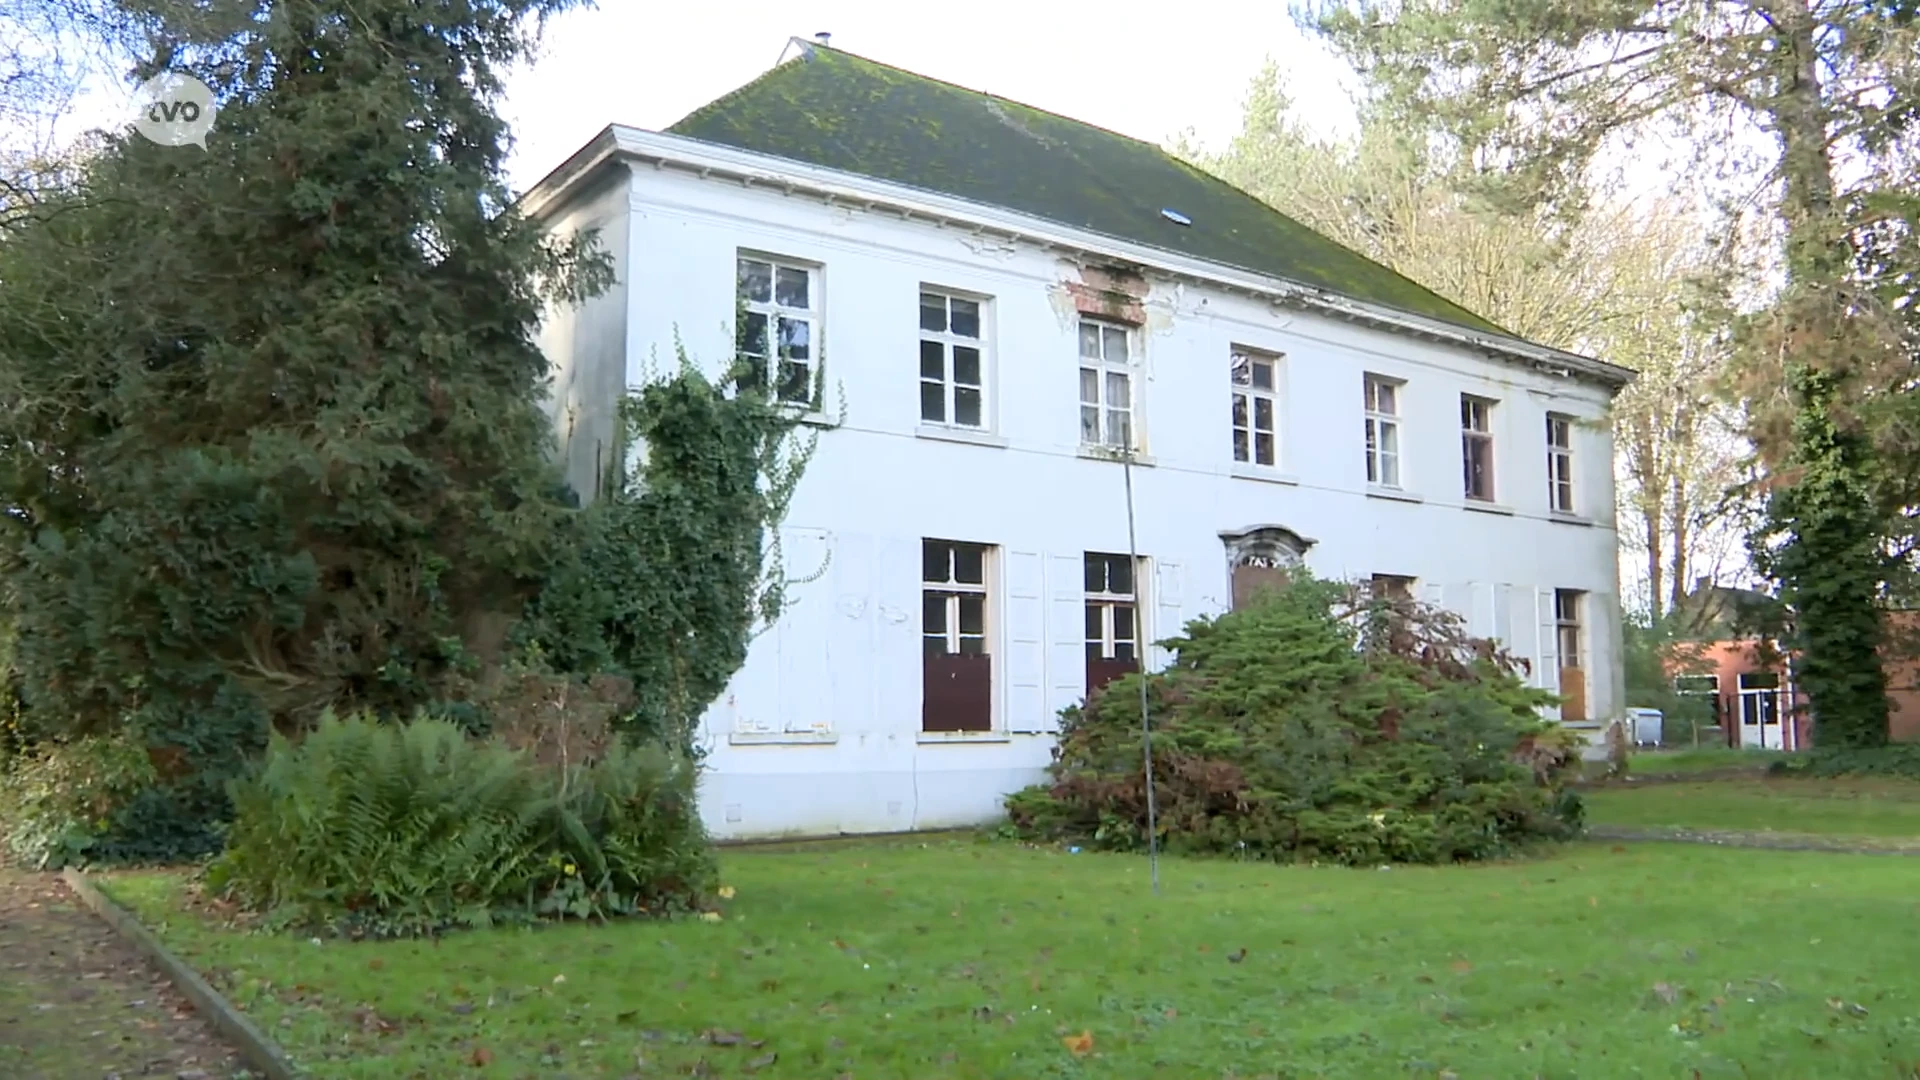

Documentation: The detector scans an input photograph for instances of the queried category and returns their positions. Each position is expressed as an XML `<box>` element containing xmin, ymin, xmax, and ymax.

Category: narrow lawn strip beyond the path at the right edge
<box><xmin>1582</xmin><ymin>778</ymin><xmax>1920</xmax><ymax>842</ymax></box>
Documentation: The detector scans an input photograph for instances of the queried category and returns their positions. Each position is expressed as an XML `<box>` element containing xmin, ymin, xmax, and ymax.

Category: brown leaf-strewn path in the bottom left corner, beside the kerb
<box><xmin>0</xmin><ymin>867</ymin><xmax>248</xmax><ymax>1080</ymax></box>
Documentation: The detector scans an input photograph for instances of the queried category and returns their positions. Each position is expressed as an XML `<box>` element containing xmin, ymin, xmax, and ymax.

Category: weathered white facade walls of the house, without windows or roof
<box><xmin>526</xmin><ymin>129</ymin><xmax>1624</xmax><ymax>836</ymax></box>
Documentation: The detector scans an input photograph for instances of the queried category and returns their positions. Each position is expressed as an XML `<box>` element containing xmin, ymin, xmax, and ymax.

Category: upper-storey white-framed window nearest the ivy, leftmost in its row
<box><xmin>735</xmin><ymin>254</ymin><xmax>820</xmax><ymax>405</ymax></box>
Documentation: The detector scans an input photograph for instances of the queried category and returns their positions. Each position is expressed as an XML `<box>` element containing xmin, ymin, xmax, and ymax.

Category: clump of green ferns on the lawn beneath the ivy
<box><xmin>207</xmin><ymin>715</ymin><xmax>716</xmax><ymax>936</ymax></box>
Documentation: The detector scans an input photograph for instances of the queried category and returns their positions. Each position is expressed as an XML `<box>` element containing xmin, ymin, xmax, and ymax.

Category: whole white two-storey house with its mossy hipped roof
<box><xmin>522</xmin><ymin>40</ymin><xmax>1630</xmax><ymax>836</ymax></box>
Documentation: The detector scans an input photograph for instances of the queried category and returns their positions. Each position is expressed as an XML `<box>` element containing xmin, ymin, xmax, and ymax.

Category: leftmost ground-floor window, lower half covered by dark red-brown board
<box><xmin>920</xmin><ymin>540</ymin><xmax>993</xmax><ymax>732</ymax></box>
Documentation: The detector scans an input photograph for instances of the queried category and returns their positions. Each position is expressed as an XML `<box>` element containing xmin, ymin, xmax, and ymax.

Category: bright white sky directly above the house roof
<box><xmin>505</xmin><ymin>0</ymin><xmax>1352</xmax><ymax>190</ymax></box>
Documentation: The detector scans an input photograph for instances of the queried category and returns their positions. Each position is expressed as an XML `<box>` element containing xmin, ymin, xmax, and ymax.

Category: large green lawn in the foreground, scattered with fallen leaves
<box><xmin>97</xmin><ymin>840</ymin><xmax>1920</xmax><ymax>1080</ymax></box>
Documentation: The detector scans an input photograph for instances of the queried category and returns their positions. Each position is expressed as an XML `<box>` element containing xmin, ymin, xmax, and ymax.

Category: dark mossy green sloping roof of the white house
<box><xmin>668</xmin><ymin>44</ymin><xmax>1500</xmax><ymax>332</ymax></box>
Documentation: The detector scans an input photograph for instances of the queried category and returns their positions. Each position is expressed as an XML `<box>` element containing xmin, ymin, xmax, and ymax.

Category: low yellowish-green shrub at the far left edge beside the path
<box><xmin>0</xmin><ymin>736</ymin><xmax>157</xmax><ymax>871</ymax></box>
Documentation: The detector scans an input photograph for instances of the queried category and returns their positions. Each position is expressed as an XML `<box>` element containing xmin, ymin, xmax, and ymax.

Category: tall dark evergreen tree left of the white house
<box><xmin>0</xmin><ymin>0</ymin><xmax>605</xmax><ymax>841</ymax></box>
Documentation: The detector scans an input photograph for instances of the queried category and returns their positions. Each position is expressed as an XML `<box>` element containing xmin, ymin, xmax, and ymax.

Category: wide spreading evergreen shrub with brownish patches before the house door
<box><xmin>1006</xmin><ymin>578</ymin><xmax>1582</xmax><ymax>865</ymax></box>
